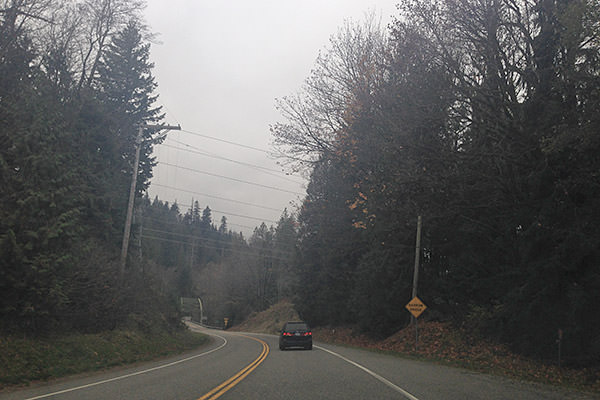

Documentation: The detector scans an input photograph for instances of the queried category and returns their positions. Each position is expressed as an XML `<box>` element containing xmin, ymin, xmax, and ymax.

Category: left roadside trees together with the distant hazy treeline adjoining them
<box><xmin>0</xmin><ymin>0</ymin><xmax>296</xmax><ymax>334</ymax></box>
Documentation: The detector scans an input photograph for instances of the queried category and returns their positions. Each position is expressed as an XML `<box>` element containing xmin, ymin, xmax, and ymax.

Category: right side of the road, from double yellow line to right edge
<box><xmin>218</xmin><ymin>334</ymin><xmax>600</xmax><ymax>400</ymax></box>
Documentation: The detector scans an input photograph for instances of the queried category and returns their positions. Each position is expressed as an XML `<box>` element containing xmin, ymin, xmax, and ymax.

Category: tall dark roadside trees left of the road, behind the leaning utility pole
<box><xmin>0</xmin><ymin>0</ymin><xmax>177</xmax><ymax>334</ymax></box>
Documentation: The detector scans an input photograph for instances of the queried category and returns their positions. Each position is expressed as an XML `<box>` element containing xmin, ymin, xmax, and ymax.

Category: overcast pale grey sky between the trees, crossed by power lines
<box><xmin>145</xmin><ymin>0</ymin><xmax>396</xmax><ymax>237</ymax></box>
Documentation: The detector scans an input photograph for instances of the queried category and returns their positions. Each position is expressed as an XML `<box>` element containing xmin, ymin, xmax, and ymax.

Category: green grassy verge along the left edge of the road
<box><xmin>0</xmin><ymin>331</ymin><xmax>208</xmax><ymax>388</ymax></box>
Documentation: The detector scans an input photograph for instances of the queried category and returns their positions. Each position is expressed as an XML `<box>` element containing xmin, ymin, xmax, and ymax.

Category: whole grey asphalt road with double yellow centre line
<box><xmin>0</xmin><ymin>327</ymin><xmax>600</xmax><ymax>400</ymax></box>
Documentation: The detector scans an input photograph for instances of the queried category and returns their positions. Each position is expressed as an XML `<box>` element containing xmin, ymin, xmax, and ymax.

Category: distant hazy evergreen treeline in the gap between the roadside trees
<box><xmin>135</xmin><ymin>197</ymin><xmax>296</xmax><ymax>326</ymax></box>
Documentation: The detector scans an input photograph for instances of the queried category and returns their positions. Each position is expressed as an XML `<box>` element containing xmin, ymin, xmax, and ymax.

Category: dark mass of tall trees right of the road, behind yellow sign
<box><xmin>272</xmin><ymin>0</ymin><xmax>600</xmax><ymax>363</ymax></box>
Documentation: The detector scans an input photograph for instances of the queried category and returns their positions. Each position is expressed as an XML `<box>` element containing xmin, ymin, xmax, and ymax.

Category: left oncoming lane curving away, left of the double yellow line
<box><xmin>0</xmin><ymin>324</ymin><xmax>269</xmax><ymax>400</ymax></box>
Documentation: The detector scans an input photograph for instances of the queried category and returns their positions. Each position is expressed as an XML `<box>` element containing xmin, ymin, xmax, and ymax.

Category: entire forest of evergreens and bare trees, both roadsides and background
<box><xmin>0</xmin><ymin>0</ymin><xmax>600</xmax><ymax>365</ymax></box>
